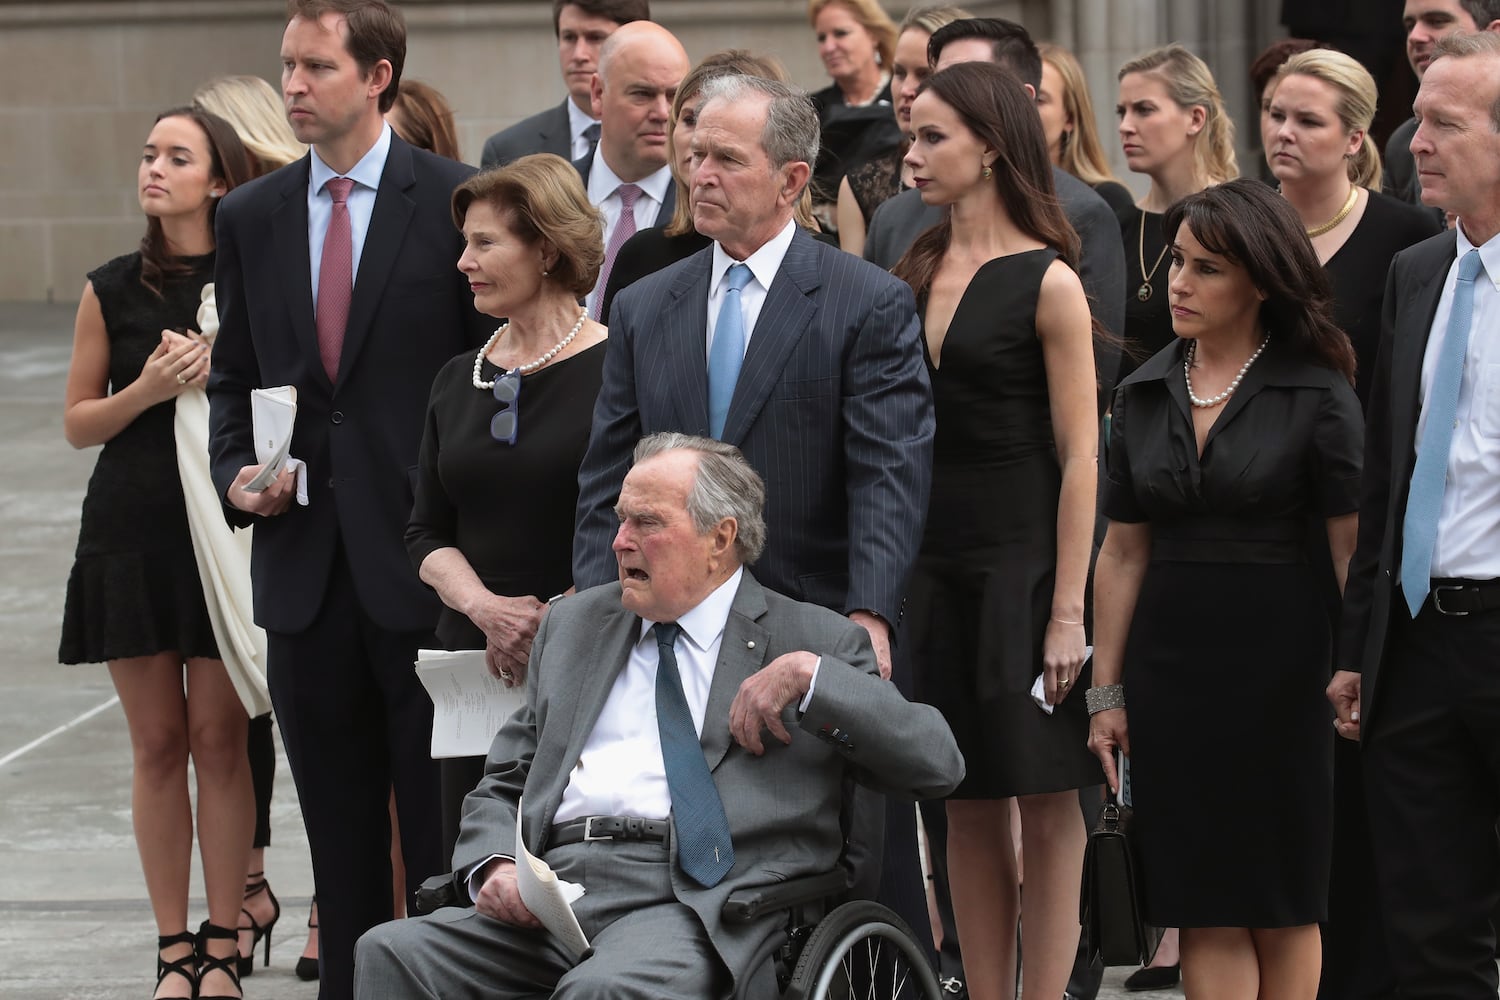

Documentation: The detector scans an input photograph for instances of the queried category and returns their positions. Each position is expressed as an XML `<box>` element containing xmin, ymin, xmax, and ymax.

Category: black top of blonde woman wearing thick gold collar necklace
<box><xmin>1325</xmin><ymin>190</ymin><xmax>1440</xmax><ymax>406</ymax></box>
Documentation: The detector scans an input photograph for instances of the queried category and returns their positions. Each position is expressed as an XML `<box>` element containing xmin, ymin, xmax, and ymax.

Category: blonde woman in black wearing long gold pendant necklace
<box><xmin>1115</xmin><ymin>43</ymin><xmax>1239</xmax><ymax>378</ymax></box>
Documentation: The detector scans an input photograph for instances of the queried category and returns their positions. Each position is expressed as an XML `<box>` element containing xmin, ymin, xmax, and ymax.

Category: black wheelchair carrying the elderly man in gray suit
<box><xmin>414</xmin><ymin>868</ymin><xmax>947</xmax><ymax>1000</ymax></box>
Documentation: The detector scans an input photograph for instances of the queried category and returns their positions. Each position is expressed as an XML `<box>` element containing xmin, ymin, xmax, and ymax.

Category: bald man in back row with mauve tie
<box><xmin>573</xmin><ymin>21</ymin><xmax>693</xmax><ymax>319</ymax></box>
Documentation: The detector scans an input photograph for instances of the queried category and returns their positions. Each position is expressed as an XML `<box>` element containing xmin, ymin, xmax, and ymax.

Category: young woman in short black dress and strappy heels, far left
<box><xmin>59</xmin><ymin>108</ymin><xmax>255</xmax><ymax>1000</ymax></box>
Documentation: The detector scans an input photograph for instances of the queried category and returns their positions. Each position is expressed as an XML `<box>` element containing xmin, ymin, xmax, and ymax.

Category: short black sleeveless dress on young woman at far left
<box><xmin>57</xmin><ymin>253</ymin><xmax>219</xmax><ymax>663</ymax></box>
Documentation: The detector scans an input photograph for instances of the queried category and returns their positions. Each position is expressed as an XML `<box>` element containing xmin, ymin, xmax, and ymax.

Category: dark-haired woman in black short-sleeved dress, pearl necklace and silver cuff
<box><xmin>1088</xmin><ymin>180</ymin><xmax>1364</xmax><ymax>1000</ymax></box>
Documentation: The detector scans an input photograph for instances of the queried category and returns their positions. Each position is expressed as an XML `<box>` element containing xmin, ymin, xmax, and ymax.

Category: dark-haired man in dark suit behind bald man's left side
<box><xmin>480</xmin><ymin>0</ymin><xmax>651</xmax><ymax>169</ymax></box>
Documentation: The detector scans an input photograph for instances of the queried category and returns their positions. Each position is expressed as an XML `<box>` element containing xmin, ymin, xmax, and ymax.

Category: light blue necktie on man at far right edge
<box><xmin>1401</xmin><ymin>250</ymin><xmax>1485</xmax><ymax>618</ymax></box>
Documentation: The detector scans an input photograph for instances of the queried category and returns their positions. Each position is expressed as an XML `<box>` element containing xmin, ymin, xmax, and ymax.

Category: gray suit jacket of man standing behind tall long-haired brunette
<box><xmin>864</xmin><ymin>166</ymin><xmax>1125</xmax><ymax>398</ymax></box>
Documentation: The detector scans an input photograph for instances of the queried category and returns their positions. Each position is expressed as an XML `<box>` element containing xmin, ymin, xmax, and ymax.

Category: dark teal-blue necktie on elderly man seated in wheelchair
<box><xmin>656</xmin><ymin>622</ymin><xmax>735</xmax><ymax>889</ymax></box>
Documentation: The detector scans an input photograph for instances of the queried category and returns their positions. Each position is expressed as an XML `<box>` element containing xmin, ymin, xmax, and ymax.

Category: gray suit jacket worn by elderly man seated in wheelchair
<box><xmin>453</xmin><ymin>571</ymin><xmax>963</xmax><ymax>981</ymax></box>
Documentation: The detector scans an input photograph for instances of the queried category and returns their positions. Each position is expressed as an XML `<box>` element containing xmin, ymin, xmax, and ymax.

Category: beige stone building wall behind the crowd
<box><xmin>0</xmin><ymin>0</ymin><xmax>1275</xmax><ymax>301</ymax></box>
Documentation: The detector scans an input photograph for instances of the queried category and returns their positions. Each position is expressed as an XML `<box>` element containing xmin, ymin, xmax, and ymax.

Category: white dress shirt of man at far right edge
<box><xmin>1416</xmin><ymin>223</ymin><xmax>1500</xmax><ymax>580</ymax></box>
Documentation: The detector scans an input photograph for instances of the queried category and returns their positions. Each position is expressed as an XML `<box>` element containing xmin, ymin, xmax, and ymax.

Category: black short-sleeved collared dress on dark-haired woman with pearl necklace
<box><xmin>1104</xmin><ymin>339</ymin><xmax>1364</xmax><ymax>928</ymax></box>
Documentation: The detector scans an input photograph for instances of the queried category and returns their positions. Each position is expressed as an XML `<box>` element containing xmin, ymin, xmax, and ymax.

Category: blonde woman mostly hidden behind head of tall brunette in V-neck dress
<box><xmin>1037</xmin><ymin>42</ymin><xmax>1136</xmax><ymax>214</ymax></box>
